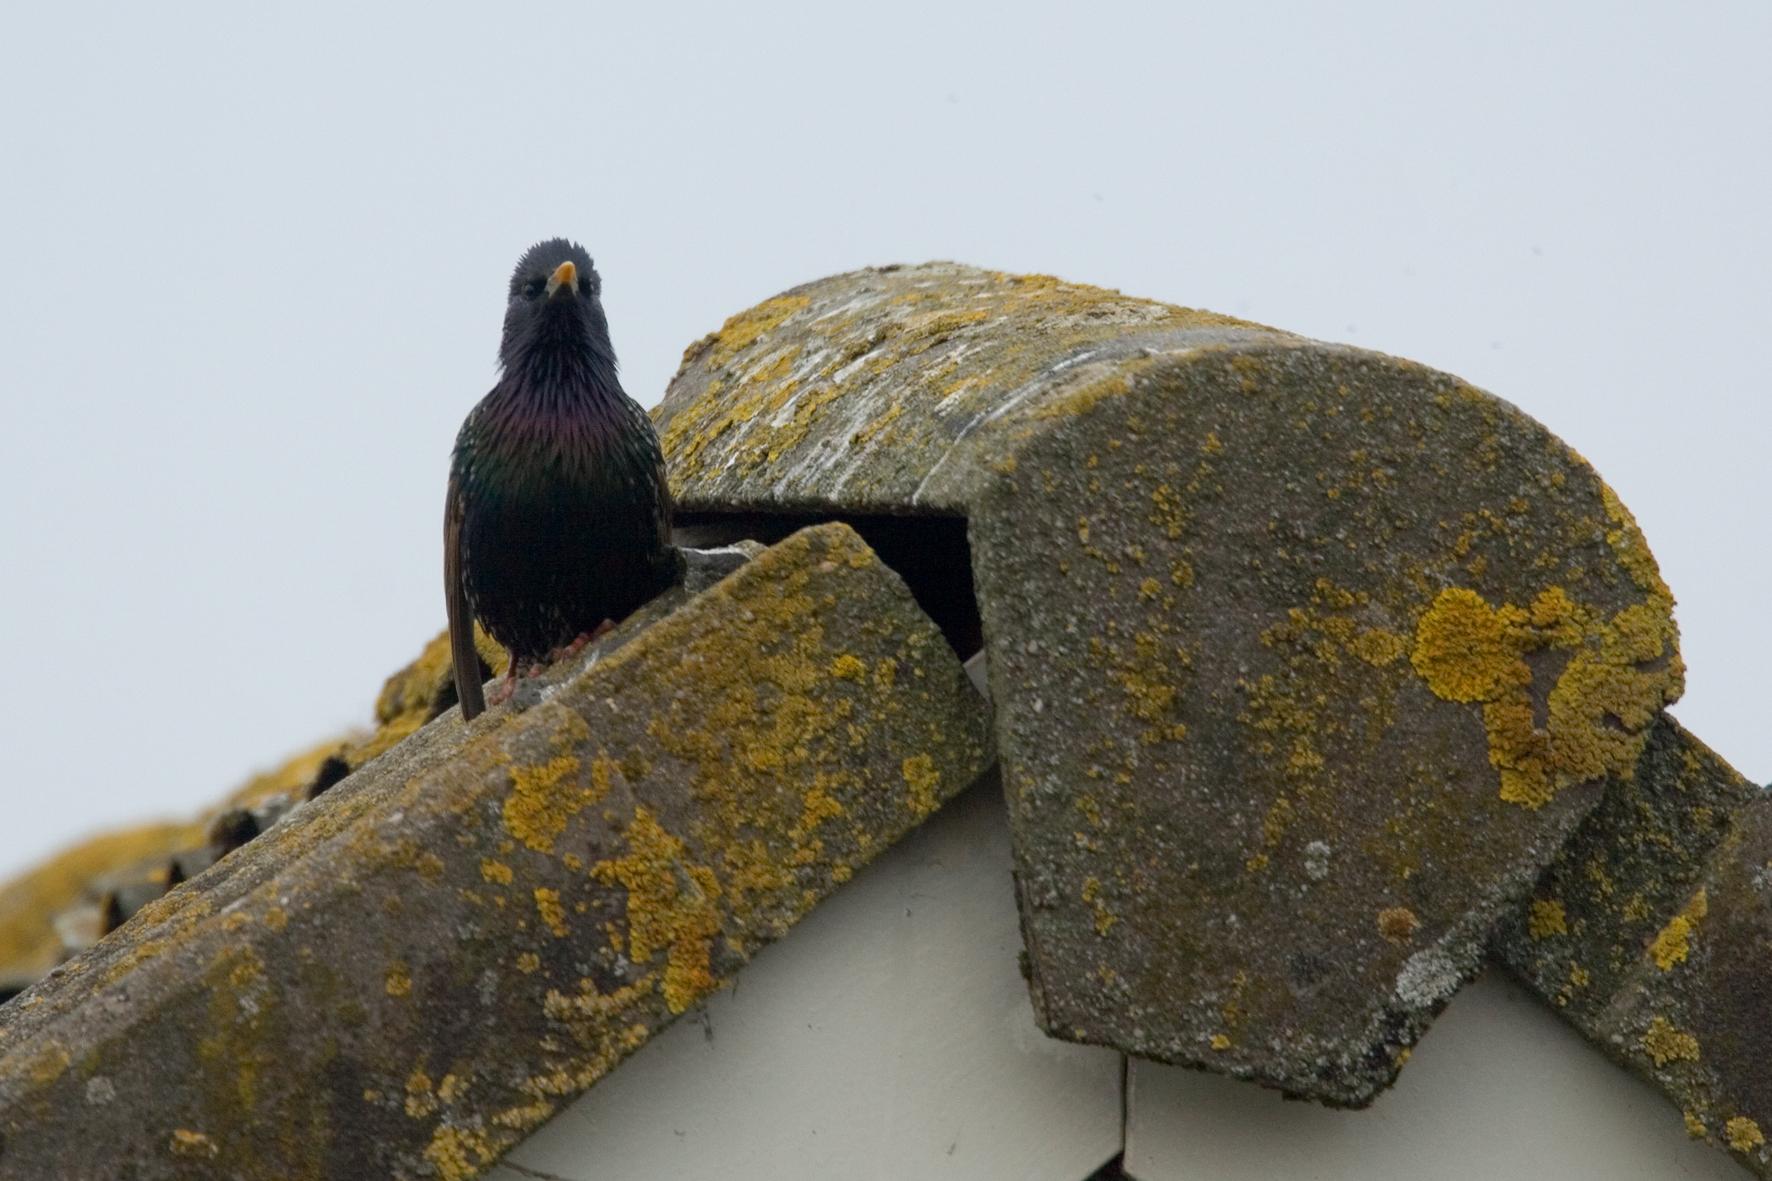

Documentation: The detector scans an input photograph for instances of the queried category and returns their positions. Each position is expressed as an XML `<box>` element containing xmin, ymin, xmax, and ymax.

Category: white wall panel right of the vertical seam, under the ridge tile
<box><xmin>1125</xmin><ymin>972</ymin><xmax>1747</xmax><ymax>1181</ymax></box>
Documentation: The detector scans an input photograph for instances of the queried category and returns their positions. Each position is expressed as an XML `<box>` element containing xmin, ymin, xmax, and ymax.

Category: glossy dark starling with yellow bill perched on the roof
<box><xmin>443</xmin><ymin>238</ymin><xmax>682</xmax><ymax>718</ymax></box>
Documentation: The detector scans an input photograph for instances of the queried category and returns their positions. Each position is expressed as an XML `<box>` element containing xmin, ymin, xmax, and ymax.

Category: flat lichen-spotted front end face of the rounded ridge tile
<box><xmin>971</xmin><ymin>346</ymin><xmax>1680</xmax><ymax>1105</ymax></box>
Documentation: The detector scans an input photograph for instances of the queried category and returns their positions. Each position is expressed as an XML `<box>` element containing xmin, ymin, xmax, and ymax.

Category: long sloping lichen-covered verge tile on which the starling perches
<box><xmin>0</xmin><ymin>525</ymin><xmax>991</xmax><ymax>1181</ymax></box>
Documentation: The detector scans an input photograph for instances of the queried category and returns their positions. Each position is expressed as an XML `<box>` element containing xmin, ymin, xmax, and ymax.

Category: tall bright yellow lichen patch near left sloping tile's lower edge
<box><xmin>590</xmin><ymin>807</ymin><xmax>719</xmax><ymax>1013</ymax></box>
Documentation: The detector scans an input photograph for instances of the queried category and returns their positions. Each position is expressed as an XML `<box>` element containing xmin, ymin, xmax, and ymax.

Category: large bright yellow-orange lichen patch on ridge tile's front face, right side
<box><xmin>1411</xmin><ymin>587</ymin><xmax>1683</xmax><ymax>809</ymax></box>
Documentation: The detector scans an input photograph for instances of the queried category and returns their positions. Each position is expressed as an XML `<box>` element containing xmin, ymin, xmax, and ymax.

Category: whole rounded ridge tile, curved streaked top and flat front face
<box><xmin>657</xmin><ymin>262</ymin><xmax>1683</xmax><ymax>1105</ymax></box>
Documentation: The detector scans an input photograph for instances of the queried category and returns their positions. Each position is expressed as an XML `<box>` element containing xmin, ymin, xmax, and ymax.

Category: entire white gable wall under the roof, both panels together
<box><xmin>491</xmin><ymin>784</ymin><xmax>1744</xmax><ymax>1181</ymax></box>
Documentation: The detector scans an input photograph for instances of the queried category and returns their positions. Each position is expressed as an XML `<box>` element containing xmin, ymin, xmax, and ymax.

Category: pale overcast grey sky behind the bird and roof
<box><xmin>0</xmin><ymin>0</ymin><xmax>1772</xmax><ymax>872</ymax></box>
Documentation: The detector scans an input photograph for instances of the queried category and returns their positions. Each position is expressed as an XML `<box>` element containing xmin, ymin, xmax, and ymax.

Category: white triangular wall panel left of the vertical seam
<box><xmin>491</xmin><ymin>784</ymin><xmax>1122</xmax><ymax>1181</ymax></box>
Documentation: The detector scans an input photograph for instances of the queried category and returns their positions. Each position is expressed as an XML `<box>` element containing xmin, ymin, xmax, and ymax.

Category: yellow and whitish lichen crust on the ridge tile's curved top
<box><xmin>657</xmin><ymin>271</ymin><xmax>1261</xmax><ymax>488</ymax></box>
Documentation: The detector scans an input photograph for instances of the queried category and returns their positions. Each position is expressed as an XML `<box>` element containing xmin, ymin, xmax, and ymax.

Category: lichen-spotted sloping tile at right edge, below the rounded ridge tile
<box><xmin>1494</xmin><ymin>718</ymin><xmax>1772</xmax><ymax>1177</ymax></box>
